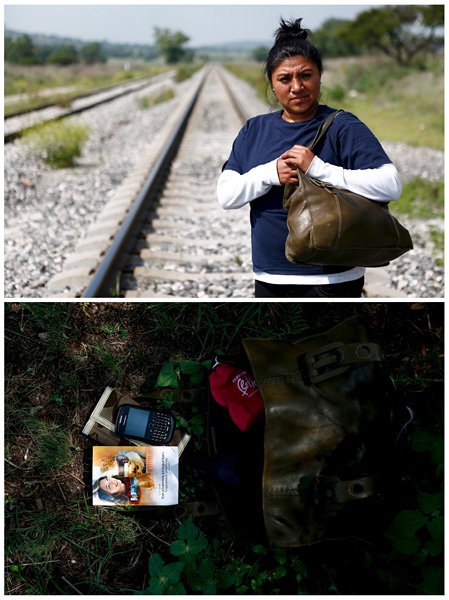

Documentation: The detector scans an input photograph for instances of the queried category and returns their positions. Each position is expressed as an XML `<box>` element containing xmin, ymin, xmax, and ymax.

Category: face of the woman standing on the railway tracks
<box><xmin>271</xmin><ymin>56</ymin><xmax>321</xmax><ymax>121</ymax></box>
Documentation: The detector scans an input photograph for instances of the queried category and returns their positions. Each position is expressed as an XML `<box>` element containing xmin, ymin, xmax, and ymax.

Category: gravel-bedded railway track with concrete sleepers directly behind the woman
<box><xmin>48</xmin><ymin>66</ymin><xmax>253</xmax><ymax>298</ymax></box>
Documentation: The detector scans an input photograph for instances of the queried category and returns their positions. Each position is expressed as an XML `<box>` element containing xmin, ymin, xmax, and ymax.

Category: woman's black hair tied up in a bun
<box><xmin>265</xmin><ymin>19</ymin><xmax>323</xmax><ymax>83</ymax></box>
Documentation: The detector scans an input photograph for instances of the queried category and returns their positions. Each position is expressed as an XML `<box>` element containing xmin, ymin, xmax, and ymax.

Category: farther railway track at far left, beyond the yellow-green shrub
<box><xmin>4</xmin><ymin>71</ymin><xmax>175</xmax><ymax>144</ymax></box>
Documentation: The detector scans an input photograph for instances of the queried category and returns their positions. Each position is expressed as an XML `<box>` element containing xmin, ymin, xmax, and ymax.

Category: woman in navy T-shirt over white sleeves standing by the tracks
<box><xmin>217</xmin><ymin>19</ymin><xmax>402</xmax><ymax>298</ymax></box>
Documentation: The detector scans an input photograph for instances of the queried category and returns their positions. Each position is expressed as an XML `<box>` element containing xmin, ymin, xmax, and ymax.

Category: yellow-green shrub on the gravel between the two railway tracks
<box><xmin>24</xmin><ymin>121</ymin><xmax>89</xmax><ymax>169</ymax></box>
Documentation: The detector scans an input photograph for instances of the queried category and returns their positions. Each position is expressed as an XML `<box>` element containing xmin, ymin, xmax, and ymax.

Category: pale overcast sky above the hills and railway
<box><xmin>4</xmin><ymin>2</ymin><xmax>372</xmax><ymax>47</ymax></box>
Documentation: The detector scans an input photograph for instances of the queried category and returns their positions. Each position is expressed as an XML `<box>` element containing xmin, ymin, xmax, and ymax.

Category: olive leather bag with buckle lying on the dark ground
<box><xmin>207</xmin><ymin>317</ymin><xmax>402</xmax><ymax>547</ymax></box>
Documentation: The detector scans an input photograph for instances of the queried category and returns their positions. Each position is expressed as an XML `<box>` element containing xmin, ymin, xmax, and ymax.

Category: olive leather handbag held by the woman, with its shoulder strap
<box><xmin>283</xmin><ymin>111</ymin><xmax>413</xmax><ymax>267</ymax></box>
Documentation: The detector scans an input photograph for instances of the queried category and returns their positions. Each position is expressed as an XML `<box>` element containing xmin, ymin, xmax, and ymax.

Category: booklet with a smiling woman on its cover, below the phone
<box><xmin>92</xmin><ymin>446</ymin><xmax>179</xmax><ymax>506</ymax></box>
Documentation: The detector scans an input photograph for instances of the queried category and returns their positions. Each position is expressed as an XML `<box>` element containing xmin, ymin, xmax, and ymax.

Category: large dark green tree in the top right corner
<box><xmin>341</xmin><ymin>5</ymin><xmax>444</xmax><ymax>65</ymax></box>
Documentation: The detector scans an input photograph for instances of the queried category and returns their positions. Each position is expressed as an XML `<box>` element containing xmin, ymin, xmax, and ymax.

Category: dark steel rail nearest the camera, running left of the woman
<box><xmin>82</xmin><ymin>71</ymin><xmax>209</xmax><ymax>298</ymax></box>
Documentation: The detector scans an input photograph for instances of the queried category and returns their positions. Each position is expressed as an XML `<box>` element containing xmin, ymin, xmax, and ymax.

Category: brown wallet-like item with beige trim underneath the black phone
<box><xmin>83</xmin><ymin>387</ymin><xmax>191</xmax><ymax>456</ymax></box>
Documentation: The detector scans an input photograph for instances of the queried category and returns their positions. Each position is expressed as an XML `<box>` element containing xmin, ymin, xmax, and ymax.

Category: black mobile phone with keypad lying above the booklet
<box><xmin>115</xmin><ymin>404</ymin><xmax>175</xmax><ymax>445</ymax></box>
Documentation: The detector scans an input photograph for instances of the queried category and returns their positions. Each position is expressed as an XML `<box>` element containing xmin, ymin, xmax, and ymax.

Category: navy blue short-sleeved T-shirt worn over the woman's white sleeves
<box><xmin>224</xmin><ymin>106</ymin><xmax>391</xmax><ymax>275</ymax></box>
